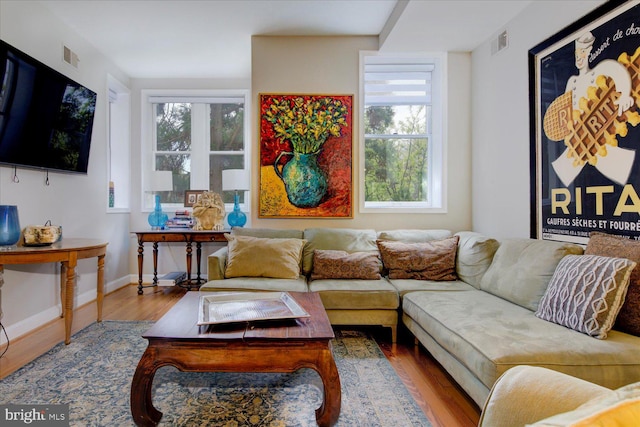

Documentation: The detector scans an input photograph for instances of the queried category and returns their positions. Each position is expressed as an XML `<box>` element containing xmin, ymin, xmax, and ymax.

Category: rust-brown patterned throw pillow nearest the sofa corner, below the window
<box><xmin>376</xmin><ymin>236</ymin><xmax>459</xmax><ymax>280</ymax></box>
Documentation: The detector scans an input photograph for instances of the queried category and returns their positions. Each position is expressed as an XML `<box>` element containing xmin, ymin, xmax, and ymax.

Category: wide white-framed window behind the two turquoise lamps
<box><xmin>143</xmin><ymin>91</ymin><xmax>249</xmax><ymax>211</ymax></box>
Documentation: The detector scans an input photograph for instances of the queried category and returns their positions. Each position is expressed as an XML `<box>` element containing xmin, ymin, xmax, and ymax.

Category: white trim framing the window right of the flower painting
<box><xmin>358</xmin><ymin>51</ymin><xmax>448</xmax><ymax>214</ymax></box>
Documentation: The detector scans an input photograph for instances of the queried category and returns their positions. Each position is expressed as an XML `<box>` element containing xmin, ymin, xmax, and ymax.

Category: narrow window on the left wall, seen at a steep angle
<box><xmin>105</xmin><ymin>76</ymin><xmax>131</xmax><ymax>212</ymax></box>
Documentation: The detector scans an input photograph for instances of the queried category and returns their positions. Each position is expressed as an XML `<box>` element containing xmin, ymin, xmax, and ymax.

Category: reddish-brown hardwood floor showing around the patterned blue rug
<box><xmin>0</xmin><ymin>284</ymin><xmax>480</xmax><ymax>427</ymax></box>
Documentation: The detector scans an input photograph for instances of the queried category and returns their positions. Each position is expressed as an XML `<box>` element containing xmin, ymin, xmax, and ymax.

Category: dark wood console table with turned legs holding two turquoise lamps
<box><xmin>134</xmin><ymin>229</ymin><xmax>230</xmax><ymax>295</ymax></box>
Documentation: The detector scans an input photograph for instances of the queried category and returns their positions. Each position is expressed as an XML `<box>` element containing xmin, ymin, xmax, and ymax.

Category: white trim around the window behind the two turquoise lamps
<box><xmin>140</xmin><ymin>89</ymin><xmax>251</xmax><ymax>213</ymax></box>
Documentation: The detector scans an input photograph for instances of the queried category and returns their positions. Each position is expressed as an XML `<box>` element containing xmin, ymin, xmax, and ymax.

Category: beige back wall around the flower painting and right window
<box><xmin>251</xmin><ymin>36</ymin><xmax>471</xmax><ymax>231</ymax></box>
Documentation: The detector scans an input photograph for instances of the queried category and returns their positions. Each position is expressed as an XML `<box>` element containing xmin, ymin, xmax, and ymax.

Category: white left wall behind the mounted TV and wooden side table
<box><xmin>0</xmin><ymin>1</ymin><xmax>130</xmax><ymax>339</ymax></box>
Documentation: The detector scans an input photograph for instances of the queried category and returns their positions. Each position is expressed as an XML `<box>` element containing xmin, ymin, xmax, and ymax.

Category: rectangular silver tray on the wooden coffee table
<box><xmin>198</xmin><ymin>292</ymin><xmax>309</xmax><ymax>325</ymax></box>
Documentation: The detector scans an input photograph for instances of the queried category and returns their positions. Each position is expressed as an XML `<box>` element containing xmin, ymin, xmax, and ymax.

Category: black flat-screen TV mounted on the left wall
<box><xmin>0</xmin><ymin>40</ymin><xmax>96</xmax><ymax>174</ymax></box>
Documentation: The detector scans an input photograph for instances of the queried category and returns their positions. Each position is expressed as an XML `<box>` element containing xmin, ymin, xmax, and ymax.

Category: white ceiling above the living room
<box><xmin>40</xmin><ymin>0</ymin><xmax>531</xmax><ymax>79</ymax></box>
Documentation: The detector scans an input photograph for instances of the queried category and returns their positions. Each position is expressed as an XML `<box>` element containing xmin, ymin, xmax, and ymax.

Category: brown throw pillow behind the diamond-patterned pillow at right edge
<box><xmin>585</xmin><ymin>232</ymin><xmax>640</xmax><ymax>336</ymax></box>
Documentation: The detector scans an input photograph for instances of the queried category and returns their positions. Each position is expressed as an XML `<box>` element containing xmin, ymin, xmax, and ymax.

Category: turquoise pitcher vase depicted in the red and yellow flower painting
<box><xmin>274</xmin><ymin>151</ymin><xmax>327</xmax><ymax>208</ymax></box>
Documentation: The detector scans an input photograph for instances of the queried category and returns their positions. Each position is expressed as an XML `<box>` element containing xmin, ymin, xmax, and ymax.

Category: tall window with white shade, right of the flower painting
<box><xmin>360</xmin><ymin>52</ymin><xmax>446</xmax><ymax>212</ymax></box>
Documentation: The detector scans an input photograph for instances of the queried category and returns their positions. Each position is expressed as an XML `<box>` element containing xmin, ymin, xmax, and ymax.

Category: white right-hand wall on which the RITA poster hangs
<box><xmin>471</xmin><ymin>1</ymin><xmax>603</xmax><ymax>237</ymax></box>
